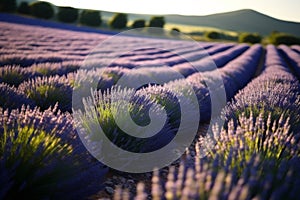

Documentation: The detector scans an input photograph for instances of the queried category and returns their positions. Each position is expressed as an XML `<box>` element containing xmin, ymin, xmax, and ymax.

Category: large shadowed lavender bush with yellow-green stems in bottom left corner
<box><xmin>0</xmin><ymin>107</ymin><xmax>106</xmax><ymax>199</ymax></box>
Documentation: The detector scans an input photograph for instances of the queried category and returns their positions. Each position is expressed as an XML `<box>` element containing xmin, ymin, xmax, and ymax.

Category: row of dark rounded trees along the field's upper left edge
<box><xmin>0</xmin><ymin>0</ymin><xmax>165</xmax><ymax>29</ymax></box>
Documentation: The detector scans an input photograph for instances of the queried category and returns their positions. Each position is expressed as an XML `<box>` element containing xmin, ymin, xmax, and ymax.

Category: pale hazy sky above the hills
<box><xmin>44</xmin><ymin>0</ymin><xmax>300</xmax><ymax>22</ymax></box>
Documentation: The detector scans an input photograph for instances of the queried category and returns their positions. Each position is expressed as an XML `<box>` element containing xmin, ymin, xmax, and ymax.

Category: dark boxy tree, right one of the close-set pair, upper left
<box><xmin>79</xmin><ymin>10</ymin><xmax>102</xmax><ymax>26</ymax></box>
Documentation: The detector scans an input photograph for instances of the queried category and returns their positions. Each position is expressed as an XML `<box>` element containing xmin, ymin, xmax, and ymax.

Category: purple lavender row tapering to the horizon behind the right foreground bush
<box><xmin>225</xmin><ymin>46</ymin><xmax>300</xmax><ymax>131</ymax></box>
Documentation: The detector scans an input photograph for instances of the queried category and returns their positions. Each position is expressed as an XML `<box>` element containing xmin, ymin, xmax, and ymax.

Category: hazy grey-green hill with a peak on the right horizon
<box><xmin>166</xmin><ymin>9</ymin><xmax>300</xmax><ymax>36</ymax></box>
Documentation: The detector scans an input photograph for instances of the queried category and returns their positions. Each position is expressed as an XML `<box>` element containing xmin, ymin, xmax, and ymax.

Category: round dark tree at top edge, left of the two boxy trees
<box><xmin>30</xmin><ymin>1</ymin><xmax>54</xmax><ymax>19</ymax></box>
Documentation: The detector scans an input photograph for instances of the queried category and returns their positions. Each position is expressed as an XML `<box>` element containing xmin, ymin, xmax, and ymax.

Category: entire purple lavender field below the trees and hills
<box><xmin>0</xmin><ymin>16</ymin><xmax>300</xmax><ymax>200</ymax></box>
